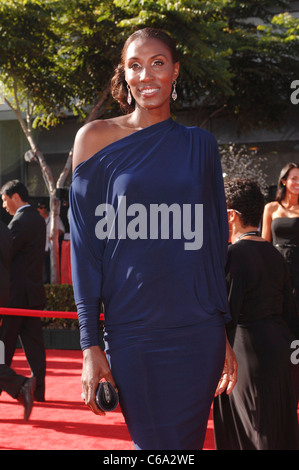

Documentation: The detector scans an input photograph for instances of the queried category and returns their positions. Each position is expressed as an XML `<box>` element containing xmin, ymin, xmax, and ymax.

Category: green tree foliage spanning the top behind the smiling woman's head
<box><xmin>0</xmin><ymin>0</ymin><xmax>299</xmax><ymax>129</ymax></box>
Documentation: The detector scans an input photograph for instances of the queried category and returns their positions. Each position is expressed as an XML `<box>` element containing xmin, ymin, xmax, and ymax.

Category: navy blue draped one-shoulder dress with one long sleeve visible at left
<box><xmin>70</xmin><ymin>119</ymin><xmax>230</xmax><ymax>449</ymax></box>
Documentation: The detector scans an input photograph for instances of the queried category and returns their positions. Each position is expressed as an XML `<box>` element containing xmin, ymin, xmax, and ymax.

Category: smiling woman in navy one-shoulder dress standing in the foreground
<box><xmin>70</xmin><ymin>28</ymin><xmax>237</xmax><ymax>450</ymax></box>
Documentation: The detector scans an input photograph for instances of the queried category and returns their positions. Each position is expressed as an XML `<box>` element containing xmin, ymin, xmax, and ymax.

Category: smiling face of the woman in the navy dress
<box><xmin>124</xmin><ymin>38</ymin><xmax>179</xmax><ymax>109</ymax></box>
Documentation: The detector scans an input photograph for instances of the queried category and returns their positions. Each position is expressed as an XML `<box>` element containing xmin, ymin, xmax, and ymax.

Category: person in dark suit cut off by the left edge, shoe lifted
<box><xmin>0</xmin><ymin>221</ymin><xmax>36</xmax><ymax>421</ymax></box>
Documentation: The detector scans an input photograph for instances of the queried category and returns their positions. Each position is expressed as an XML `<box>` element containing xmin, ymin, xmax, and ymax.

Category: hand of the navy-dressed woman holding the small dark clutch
<box><xmin>81</xmin><ymin>346</ymin><xmax>116</xmax><ymax>415</ymax></box>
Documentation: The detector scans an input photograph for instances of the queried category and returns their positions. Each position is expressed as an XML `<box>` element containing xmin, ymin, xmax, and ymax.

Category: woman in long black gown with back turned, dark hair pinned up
<box><xmin>214</xmin><ymin>180</ymin><xmax>299</xmax><ymax>450</ymax></box>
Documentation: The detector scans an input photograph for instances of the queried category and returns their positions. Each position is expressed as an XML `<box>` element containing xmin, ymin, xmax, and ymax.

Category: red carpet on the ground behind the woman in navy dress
<box><xmin>0</xmin><ymin>350</ymin><xmax>215</xmax><ymax>450</ymax></box>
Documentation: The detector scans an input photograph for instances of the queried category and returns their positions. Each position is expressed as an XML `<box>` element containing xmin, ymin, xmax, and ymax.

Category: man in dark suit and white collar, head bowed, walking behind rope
<box><xmin>0</xmin><ymin>180</ymin><xmax>46</xmax><ymax>401</ymax></box>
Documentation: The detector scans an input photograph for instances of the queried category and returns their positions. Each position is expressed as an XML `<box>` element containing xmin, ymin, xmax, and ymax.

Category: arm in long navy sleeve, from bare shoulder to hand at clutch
<box><xmin>70</xmin><ymin>122</ymin><xmax>115</xmax><ymax>415</ymax></box>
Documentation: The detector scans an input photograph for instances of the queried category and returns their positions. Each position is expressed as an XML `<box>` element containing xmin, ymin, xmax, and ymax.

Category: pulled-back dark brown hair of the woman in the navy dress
<box><xmin>111</xmin><ymin>28</ymin><xmax>179</xmax><ymax>113</ymax></box>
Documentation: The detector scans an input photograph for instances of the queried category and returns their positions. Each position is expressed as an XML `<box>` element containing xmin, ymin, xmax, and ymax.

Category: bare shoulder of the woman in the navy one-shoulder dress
<box><xmin>73</xmin><ymin>116</ymin><xmax>131</xmax><ymax>169</ymax></box>
